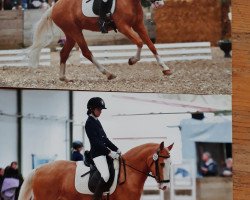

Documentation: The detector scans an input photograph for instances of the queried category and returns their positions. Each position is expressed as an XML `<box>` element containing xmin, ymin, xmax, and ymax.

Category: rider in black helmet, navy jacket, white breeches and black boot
<box><xmin>85</xmin><ymin>97</ymin><xmax>121</xmax><ymax>200</ymax></box>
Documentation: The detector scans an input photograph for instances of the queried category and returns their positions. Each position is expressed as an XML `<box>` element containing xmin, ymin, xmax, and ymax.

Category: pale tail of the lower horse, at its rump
<box><xmin>18</xmin><ymin>170</ymin><xmax>35</xmax><ymax>200</ymax></box>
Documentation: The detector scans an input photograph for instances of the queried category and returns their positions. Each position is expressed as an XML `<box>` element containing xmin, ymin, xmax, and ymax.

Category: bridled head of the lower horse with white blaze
<box><xmin>147</xmin><ymin>142</ymin><xmax>173</xmax><ymax>190</ymax></box>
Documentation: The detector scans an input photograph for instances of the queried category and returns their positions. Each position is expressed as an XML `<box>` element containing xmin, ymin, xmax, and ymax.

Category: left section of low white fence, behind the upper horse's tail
<box><xmin>0</xmin><ymin>48</ymin><xmax>51</xmax><ymax>67</ymax></box>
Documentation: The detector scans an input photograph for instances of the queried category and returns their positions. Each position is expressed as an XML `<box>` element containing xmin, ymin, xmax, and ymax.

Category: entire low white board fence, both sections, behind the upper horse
<box><xmin>0</xmin><ymin>42</ymin><xmax>212</xmax><ymax>67</ymax></box>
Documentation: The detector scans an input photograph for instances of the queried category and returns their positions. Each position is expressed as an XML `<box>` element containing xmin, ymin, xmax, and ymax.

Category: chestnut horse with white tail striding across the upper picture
<box><xmin>28</xmin><ymin>0</ymin><xmax>172</xmax><ymax>82</ymax></box>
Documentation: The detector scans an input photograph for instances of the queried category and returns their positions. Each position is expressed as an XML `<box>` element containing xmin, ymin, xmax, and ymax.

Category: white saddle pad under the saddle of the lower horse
<box><xmin>75</xmin><ymin>160</ymin><xmax>119</xmax><ymax>194</ymax></box>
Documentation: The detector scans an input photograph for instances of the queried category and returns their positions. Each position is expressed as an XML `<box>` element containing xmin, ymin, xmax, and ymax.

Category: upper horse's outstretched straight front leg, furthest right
<box><xmin>133</xmin><ymin>21</ymin><xmax>172</xmax><ymax>75</ymax></box>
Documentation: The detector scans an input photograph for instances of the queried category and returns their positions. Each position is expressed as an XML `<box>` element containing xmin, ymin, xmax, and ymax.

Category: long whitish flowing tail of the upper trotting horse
<box><xmin>28</xmin><ymin>7</ymin><xmax>58</xmax><ymax>67</ymax></box>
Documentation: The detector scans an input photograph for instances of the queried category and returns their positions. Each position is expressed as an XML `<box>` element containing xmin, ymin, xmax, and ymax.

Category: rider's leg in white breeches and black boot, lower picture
<box><xmin>93</xmin><ymin>156</ymin><xmax>110</xmax><ymax>200</ymax></box>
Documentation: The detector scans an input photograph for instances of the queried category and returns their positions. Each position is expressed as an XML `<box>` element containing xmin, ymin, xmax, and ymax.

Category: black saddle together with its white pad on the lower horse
<box><xmin>75</xmin><ymin>151</ymin><xmax>119</xmax><ymax>194</ymax></box>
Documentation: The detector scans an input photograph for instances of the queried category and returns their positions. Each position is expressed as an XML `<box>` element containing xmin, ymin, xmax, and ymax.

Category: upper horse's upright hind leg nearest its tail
<box><xmin>59</xmin><ymin>35</ymin><xmax>75</xmax><ymax>82</ymax></box>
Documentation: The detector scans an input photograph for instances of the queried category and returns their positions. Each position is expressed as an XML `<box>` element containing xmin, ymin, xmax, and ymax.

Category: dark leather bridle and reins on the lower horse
<box><xmin>119</xmin><ymin>149</ymin><xmax>170</xmax><ymax>185</ymax></box>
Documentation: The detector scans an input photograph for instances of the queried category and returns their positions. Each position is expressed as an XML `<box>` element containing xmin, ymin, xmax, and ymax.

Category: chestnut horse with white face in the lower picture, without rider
<box><xmin>18</xmin><ymin>142</ymin><xmax>173</xmax><ymax>200</ymax></box>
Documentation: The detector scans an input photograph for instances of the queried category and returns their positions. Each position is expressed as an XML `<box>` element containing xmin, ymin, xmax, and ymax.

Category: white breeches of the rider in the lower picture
<box><xmin>93</xmin><ymin>156</ymin><xmax>110</xmax><ymax>183</ymax></box>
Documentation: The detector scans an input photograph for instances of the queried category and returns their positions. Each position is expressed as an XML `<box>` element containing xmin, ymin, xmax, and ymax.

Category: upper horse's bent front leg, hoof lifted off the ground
<box><xmin>119</xmin><ymin>26</ymin><xmax>143</xmax><ymax>65</ymax></box>
